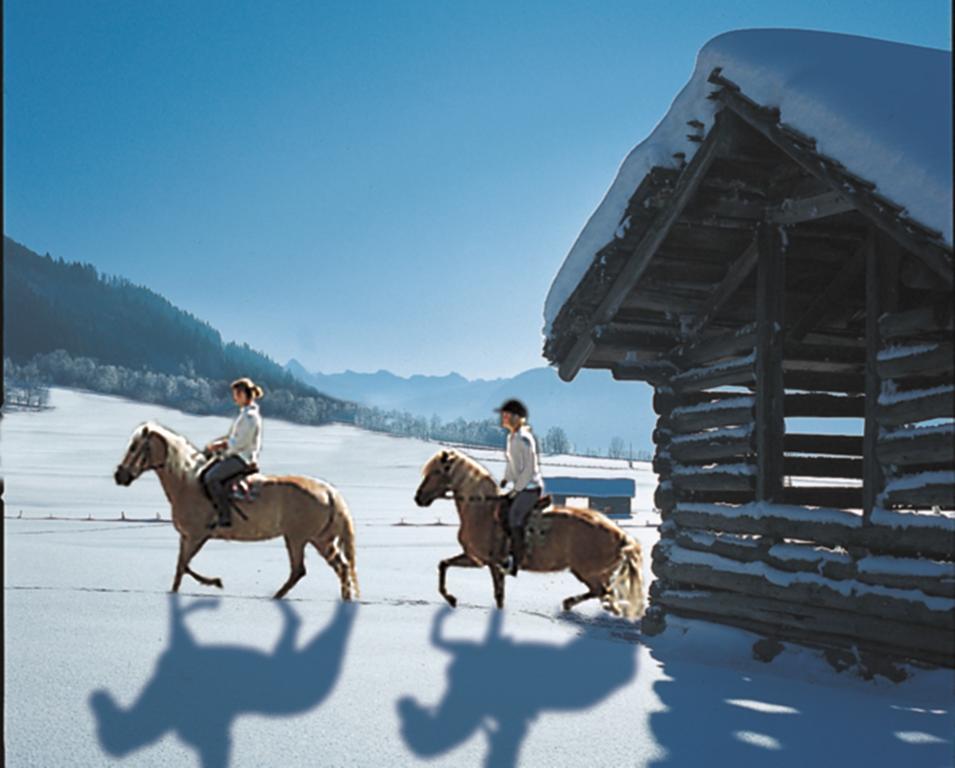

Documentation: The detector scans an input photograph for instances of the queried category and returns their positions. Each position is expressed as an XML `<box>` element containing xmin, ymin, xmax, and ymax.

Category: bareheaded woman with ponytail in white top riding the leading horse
<box><xmin>202</xmin><ymin>377</ymin><xmax>263</xmax><ymax>528</ymax></box>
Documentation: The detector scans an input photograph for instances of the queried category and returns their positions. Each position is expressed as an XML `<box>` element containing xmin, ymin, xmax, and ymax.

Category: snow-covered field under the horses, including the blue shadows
<box><xmin>0</xmin><ymin>390</ymin><xmax>953</xmax><ymax>767</ymax></box>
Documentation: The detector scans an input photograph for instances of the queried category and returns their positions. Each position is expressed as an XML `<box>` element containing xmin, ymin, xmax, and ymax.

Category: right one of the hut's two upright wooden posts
<box><xmin>862</xmin><ymin>227</ymin><xmax>899</xmax><ymax>525</ymax></box>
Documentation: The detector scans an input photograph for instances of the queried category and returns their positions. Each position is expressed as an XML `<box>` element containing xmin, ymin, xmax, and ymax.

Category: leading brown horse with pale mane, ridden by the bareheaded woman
<box><xmin>114</xmin><ymin>423</ymin><xmax>358</xmax><ymax>600</ymax></box>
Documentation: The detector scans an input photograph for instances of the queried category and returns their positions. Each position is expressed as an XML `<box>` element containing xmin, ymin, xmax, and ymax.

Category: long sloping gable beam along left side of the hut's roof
<box><xmin>558</xmin><ymin>114</ymin><xmax>727</xmax><ymax>381</ymax></box>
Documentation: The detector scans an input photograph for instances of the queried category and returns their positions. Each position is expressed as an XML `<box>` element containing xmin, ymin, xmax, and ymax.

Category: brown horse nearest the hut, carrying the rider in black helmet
<box><xmin>415</xmin><ymin>451</ymin><xmax>644</xmax><ymax>619</ymax></box>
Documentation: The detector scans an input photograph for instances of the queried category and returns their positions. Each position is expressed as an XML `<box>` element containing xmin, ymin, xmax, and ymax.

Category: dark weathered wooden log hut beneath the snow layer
<box><xmin>545</xmin><ymin>37</ymin><xmax>955</xmax><ymax>666</ymax></box>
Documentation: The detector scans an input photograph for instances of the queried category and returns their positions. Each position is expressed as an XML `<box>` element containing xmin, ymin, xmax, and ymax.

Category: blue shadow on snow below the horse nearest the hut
<box><xmin>397</xmin><ymin>607</ymin><xmax>637</xmax><ymax>768</ymax></box>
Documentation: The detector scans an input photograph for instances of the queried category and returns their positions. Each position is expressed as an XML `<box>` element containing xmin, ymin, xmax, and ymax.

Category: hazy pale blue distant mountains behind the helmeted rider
<box><xmin>286</xmin><ymin>359</ymin><xmax>656</xmax><ymax>455</ymax></box>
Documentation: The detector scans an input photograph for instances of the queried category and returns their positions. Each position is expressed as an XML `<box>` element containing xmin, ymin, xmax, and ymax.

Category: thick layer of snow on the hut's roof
<box><xmin>544</xmin><ymin>29</ymin><xmax>952</xmax><ymax>337</ymax></box>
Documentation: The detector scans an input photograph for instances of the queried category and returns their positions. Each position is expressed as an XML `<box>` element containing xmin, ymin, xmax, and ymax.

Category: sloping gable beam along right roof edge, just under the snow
<box><xmin>716</xmin><ymin>88</ymin><xmax>955</xmax><ymax>287</ymax></box>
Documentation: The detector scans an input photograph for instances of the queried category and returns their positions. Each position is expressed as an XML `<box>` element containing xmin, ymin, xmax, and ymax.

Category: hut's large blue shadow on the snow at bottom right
<box><xmin>650</xmin><ymin>645</ymin><xmax>955</xmax><ymax>768</ymax></box>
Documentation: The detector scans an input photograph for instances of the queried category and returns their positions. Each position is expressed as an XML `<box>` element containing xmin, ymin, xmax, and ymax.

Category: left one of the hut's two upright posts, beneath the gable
<box><xmin>756</xmin><ymin>222</ymin><xmax>786</xmax><ymax>501</ymax></box>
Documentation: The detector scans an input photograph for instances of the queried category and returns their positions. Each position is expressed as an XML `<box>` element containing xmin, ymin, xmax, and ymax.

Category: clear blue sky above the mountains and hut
<box><xmin>3</xmin><ymin>0</ymin><xmax>951</xmax><ymax>377</ymax></box>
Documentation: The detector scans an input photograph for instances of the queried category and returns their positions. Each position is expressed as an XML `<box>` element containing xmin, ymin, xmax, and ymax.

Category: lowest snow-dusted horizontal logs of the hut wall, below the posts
<box><xmin>651</xmin><ymin>502</ymin><xmax>955</xmax><ymax>666</ymax></box>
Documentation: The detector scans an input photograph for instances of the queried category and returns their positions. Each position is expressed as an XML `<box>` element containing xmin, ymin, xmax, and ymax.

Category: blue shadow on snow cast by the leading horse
<box><xmin>90</xmin><ymin>595</ymin><xmax>357</xmax><ymax>768</ymax></box>
